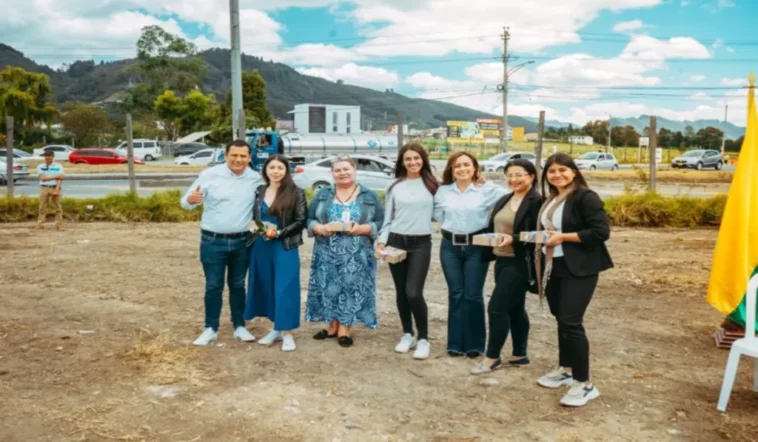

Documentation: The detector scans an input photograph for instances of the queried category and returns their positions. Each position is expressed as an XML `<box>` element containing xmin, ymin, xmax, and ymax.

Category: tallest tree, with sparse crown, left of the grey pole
<box><xmin>124</xmin><ymin>25</ymin><xmax>205</xmax><ymax>111</ymax></box>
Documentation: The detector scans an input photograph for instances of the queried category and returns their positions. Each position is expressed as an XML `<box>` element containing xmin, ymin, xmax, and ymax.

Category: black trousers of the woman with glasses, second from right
<box><xmin>487</xmin><ymin>257</ymin><xmax>529</xmax><ymax>359</ymax></box>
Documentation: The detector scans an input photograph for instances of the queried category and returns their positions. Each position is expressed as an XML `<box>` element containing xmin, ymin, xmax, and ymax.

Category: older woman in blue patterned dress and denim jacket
<box><xmin>305</xmin><ymin>156</ymin><xmax>384</xmax><ymax>347</ymax></box>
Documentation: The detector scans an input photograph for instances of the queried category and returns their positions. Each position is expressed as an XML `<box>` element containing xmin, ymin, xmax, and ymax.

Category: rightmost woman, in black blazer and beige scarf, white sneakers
<box><xmin>537</xmin><ymin>153</ymin><xmax>613</xmax><ymax>407</ymax></box>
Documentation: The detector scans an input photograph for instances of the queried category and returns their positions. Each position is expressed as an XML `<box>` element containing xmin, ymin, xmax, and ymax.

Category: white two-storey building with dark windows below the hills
<box><xmin>289</xmin><ymin>104</ymin><xmax>361</xmax><ymax>134</ymax></box>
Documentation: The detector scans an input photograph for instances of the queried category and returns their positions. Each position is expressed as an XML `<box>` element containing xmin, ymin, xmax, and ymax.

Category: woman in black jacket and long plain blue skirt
<box><xmin>245</xmin><ymin>155</ymin><xmax>308</xmax><ymax>351</ymax></box>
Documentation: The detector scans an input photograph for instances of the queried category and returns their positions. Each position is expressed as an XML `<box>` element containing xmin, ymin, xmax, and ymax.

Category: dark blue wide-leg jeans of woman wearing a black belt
<box><xmin>440</xmin><ymin>238</ymin><xmax>489</xmax><ymax>356</ymax></box>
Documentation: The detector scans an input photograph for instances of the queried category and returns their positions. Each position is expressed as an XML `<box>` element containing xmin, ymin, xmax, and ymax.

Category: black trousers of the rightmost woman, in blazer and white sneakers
<box><xmin>545</xmin><ymin>258</ymin><xmax>598</xmax><ymax>382</ymax></box>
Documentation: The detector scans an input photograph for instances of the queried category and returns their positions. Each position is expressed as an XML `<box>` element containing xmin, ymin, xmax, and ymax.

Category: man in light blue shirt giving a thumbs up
<box><xmin>181</xmin><ymin>140</ymin><xmax>260</xmax><ymax>345</ymax></box>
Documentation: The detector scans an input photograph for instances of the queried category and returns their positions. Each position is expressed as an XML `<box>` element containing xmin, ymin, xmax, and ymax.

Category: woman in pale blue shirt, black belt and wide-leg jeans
<box><xmin>434</xmin><ymin>152</ymin><xmax>510</xmax><ymax>358</ymax></box>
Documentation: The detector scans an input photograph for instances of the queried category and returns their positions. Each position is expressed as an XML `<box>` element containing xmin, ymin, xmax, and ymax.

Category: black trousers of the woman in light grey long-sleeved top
<box><xmin>387</xmin><ymin>233</ymin><xmax>432</xmax><ymax>339</ymax></box>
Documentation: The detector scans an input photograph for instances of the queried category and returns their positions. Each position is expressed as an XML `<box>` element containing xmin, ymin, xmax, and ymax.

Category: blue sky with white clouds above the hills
<box><xmin>0</xmin><ymin>0</ymin><xmax>758</xmax><ymax>124</ymax></box>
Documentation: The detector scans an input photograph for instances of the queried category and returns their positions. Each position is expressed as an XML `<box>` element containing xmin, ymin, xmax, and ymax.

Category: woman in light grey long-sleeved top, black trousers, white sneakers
<box><xmin>376</xmin><ymin>143</ymin><xmax>439</xmax><ymax>359</ymax></box>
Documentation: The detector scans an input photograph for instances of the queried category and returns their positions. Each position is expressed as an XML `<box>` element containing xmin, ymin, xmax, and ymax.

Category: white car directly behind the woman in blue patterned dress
<box><xmin>293</xmin><ymin>154</ymin><xmax>395</xmax><ymax>191</ymax></box>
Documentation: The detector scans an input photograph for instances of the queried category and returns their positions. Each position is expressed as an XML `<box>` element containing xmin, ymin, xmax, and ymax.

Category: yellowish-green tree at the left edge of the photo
<box><xmin>0</xmin><ymin>66</ymin><xmax>58</xmax><ymax>141</ymax></box>
